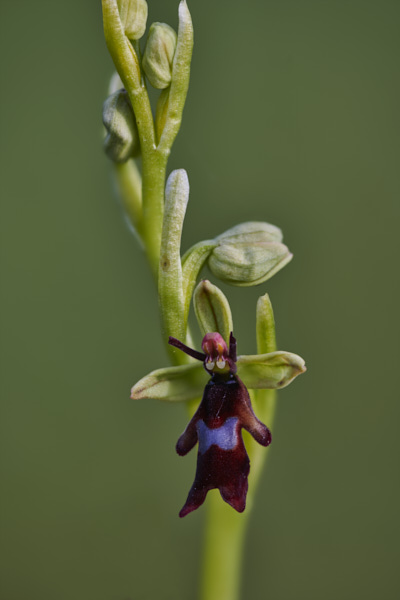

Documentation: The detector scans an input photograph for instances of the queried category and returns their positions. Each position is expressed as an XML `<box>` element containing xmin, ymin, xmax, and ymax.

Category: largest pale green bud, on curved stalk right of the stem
<box><xmin>208</xmin><ymin>222</ymin><xmax>293</xmax><ymax>287</ymax></box>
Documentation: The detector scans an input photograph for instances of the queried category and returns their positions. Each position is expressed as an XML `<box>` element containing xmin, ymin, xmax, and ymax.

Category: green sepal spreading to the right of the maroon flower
<box><xmin>237</xmin><ymin>352</ymin><xmax>306</xmax><ymax>390</ymax></box>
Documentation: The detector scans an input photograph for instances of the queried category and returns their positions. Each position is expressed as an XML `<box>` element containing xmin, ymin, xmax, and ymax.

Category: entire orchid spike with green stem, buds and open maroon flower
<box><xmin>102</xmin><ymin>0</ymin><xmax>305</xmax><ymax>600</ymax></box>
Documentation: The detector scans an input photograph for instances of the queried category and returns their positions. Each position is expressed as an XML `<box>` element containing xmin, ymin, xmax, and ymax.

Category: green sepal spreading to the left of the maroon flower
<box><xmin>131</xmin><ymin>362</ymin><xmax>209</xmax><ymax>402</ymax></box>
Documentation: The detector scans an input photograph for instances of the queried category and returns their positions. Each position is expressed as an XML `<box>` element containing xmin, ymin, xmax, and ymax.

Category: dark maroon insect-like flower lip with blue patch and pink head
<box><xmin>169</xmin><ymin>333</ymin><xmax>271</xmax><ymax>517</ymax></box>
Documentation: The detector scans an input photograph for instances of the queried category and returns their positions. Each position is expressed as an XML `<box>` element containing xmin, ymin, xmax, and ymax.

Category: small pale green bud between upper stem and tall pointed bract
<box><xmin>142</xmin><ymin>23</ymin><xmax>177</xmax><ymax>90</ymax></box>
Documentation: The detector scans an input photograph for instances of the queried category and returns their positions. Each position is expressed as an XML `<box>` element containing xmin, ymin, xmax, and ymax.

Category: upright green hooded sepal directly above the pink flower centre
<box><xmin>193</xmin><ymin>279</ymin><xmax>233</xmax><ymax>344</ymax></box>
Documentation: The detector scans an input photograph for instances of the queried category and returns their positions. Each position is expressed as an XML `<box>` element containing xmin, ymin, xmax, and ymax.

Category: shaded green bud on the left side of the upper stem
<box><xmin>103</xmin><ymin>89</ymin><xmax>140</xmax><ymax>163</ymax></box>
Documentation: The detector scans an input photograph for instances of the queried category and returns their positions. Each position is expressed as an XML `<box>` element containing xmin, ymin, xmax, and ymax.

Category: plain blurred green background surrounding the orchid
<box><xmin>0</xmin><ymin>0</ymin><xmax>400</xmax><ymax>600</ymax></box>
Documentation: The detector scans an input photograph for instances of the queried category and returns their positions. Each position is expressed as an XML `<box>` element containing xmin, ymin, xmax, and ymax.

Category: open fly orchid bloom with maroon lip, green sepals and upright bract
<box><xmin>131</xmin><ymin>280</ymin><xmax>306</xmax><ymax>517</ymax></box>
